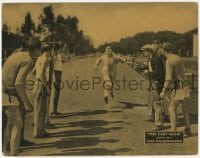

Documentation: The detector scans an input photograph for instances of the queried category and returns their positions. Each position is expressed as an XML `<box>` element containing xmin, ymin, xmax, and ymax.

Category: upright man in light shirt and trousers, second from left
<box><xmin>33</xmin><ymin>43</ymin><xmax>53</xmax><ymax>138</ymax></box>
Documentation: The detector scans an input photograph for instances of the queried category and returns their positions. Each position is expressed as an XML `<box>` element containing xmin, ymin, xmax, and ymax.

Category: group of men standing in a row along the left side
<box><xmin>2</xmin><ymin>37</ymin><xmax>63</xmax><ymax>155</ymax></box>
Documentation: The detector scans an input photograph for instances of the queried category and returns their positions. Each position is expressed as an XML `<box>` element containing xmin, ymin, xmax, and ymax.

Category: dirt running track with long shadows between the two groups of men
<box><xmin>20</xmin><ymin>57</ymin><xmax>198</xmax><ymax>155</ymax></box>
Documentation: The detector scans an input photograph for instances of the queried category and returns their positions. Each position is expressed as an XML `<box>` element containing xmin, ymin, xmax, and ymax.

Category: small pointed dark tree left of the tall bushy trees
<box><xmin>21</xmin><ymin>12</ymin><xmax>35</xmax><ymax>36</ymax></box>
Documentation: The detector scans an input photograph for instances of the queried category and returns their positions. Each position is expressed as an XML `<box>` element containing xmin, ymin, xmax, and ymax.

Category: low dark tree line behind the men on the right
<box><xmin>97</xmin><ymin>28</ymin><xmax>198</xmax><ymax>56</ymax></box>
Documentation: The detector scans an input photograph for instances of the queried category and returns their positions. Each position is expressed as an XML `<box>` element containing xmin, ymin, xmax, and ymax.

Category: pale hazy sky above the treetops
<box><xmin>2</xmin><ymin>2</ymin><xmax>198</xmax><ymax>47</ymax></box>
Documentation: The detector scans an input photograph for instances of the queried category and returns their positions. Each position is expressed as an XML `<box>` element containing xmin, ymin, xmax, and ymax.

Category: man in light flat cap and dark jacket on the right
<box><xmin>143</xmin><ymin>44</ymin><xmax>164</xmax><ymax>131</ymax></box>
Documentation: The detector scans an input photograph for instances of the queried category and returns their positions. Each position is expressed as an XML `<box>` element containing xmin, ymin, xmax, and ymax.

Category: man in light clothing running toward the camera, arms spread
<box><xmin>95</xmin><ymin>46</ymin><xmax>126</xmax><ymax>104</ymax></box>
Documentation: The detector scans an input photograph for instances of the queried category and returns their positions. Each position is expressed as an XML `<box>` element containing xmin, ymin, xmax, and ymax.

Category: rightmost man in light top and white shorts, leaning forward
<box><xmin>160</xmin><ymin>42</ymin><xmax>191</xmax><ymax>136</ymax></box>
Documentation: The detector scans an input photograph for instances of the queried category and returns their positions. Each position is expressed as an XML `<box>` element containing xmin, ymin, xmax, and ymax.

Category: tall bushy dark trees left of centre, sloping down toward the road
<box><xmin>37</xmin><ymin>5</ymin><xmax>94</xmax><ymax>55</ymax></box>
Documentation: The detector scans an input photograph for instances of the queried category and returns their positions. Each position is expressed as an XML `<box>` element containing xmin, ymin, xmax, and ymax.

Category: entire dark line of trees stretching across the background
<box><xmin>2</xmin><ymin>5</ymin><xmax>198</xmax><ymax>56</ymax></box>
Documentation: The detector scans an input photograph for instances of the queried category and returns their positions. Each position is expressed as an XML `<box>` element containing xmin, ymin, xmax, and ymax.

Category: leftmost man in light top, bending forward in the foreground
<box><xmin>2</xmin><ymin>37</ymin><xmax>41</xmax><ymax>155</ymax></box>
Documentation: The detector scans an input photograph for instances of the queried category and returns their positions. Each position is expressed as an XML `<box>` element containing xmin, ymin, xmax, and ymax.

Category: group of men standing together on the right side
<box><xmin>140</xmin><ymin>40</ymin><xmax>191</xmax><ymax>133</ymax></box>
